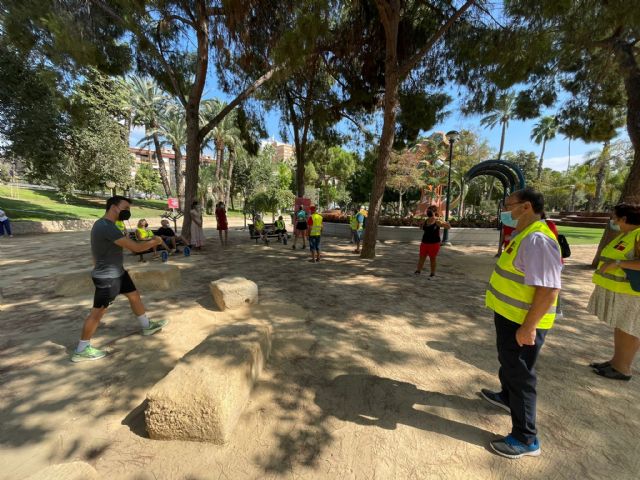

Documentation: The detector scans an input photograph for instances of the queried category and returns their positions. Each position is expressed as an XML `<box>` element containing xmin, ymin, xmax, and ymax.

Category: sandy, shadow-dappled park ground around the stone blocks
<box><xmin>0</xmin><ymin>219</ymin><xmax>640</xmax><ymax>480</ymax></box>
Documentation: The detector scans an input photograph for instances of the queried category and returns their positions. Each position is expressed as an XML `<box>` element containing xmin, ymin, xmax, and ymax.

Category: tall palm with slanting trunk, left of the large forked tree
<box><xmin>129</xmin><ymin>76</ymin><xmax>172</xmax><ymax>197</ymax></box>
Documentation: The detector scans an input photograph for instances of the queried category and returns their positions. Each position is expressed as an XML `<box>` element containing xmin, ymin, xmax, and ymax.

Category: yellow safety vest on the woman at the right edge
<box><xmin>592</xmin><ymin>228</ymin><xmax>640</xmax><ymax>297</ymax></box>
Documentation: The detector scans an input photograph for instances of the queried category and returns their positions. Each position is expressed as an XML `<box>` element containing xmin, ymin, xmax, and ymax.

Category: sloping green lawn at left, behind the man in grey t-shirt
<box><xmin>0</xmin><ymin>185</ymin><xmax>166</xmax><ymax>221</ymax></box>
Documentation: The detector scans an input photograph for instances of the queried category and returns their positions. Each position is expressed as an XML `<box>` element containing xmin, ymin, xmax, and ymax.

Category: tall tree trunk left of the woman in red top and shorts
<box><xmin>360</xmin><ymin>1</ymin><xmax>400</xmax><ymax>258</ymax></box>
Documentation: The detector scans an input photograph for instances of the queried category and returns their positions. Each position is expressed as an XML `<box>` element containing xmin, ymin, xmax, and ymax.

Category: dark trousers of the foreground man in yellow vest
<box><xmin>494</xmin><ymin>313</ymin><xmax>548</xmax><ymax>445</ymax></box>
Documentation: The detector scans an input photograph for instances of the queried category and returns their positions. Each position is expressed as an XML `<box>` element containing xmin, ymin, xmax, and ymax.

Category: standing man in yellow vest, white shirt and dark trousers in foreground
<box><xmin>480</xmin><ymin>188</ymin><xmax>562</xmax><ymax>458</ymax></box>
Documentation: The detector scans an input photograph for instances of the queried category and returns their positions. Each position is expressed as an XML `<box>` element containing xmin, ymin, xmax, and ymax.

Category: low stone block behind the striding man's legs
<box><xmin>53</xmin><ymin>263</ymin><xmax>181</xmax><ymax>297</ymax></box>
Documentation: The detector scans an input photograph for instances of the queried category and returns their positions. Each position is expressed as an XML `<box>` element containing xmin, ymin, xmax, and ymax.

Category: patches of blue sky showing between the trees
<box><xmin>130</xmin><ymin>75</ymin><xmax>627</xmax><ymax>171</ymax></box>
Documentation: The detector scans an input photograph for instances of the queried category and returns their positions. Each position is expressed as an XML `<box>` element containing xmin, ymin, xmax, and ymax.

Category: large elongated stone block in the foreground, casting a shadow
<box><xmin>145</xmin><ymin>323</ymin><xmax>271</xmax><ymax>445</ymax></box>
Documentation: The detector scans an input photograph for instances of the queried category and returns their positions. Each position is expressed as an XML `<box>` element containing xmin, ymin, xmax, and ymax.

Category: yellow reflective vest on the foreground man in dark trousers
<box><xmin>485</xmin><ymin>221</ymin><xmax>560</xmax><ymax>330</ymax></box>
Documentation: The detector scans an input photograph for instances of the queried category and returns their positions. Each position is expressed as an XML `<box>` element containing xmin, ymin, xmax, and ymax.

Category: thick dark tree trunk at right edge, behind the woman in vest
<box><xmin>591</xmin><ymin>40</ymin><xmax>640</xmax><ymax>268</ymax></box>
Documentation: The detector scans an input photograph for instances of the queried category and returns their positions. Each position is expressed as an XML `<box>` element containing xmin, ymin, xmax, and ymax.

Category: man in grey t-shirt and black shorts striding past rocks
<box><xmin>71</xmin><ymin>196</ymin><xmax>168</xmax><ymax>362</ymax></box>
